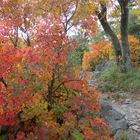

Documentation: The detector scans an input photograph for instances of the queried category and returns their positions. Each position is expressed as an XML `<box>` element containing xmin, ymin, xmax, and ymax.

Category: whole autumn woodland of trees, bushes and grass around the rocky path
<box><xmin>0</xmin><ymin>0</ymin><xmax>140</xmax><ymax>140</ymax></box>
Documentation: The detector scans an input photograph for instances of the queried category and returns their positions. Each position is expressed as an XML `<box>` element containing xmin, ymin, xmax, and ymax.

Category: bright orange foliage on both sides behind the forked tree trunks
<box><xmin>82</xmin><ymin>35</ymin><xmax>140</xmax><ymax>70</ymax></box>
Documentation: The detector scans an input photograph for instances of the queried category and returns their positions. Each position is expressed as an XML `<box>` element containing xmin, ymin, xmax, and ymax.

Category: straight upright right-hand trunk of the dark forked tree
<box><xmin>118</xmin><ymin>0</ymin><xmax>132</xmax><ymax>72</ymax></box>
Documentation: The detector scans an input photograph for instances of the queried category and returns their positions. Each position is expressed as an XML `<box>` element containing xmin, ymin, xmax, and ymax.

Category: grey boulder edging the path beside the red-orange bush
<box><xmin>100</xmin><ymin>96</ymin><xmax>140</xmax><ymax>140</ymax></box>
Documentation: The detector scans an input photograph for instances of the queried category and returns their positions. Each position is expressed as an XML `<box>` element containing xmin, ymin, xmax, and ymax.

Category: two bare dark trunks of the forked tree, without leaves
<box><xmin>97</xmin><ymin>0</ymin><xmax>131</xmax><ymax>71</ymax></box>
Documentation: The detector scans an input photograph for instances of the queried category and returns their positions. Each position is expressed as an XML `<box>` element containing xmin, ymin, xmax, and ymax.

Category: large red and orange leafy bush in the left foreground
<box><xmin>0</xmin><ymin>17</ymin><xmax>111</xmax><ymax>140</ymax></box>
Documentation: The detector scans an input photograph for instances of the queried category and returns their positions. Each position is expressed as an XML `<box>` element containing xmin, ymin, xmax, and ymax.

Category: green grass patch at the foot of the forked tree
<box><xmin>98</xmin><ymin>65</ymin><xmax>140</xmax><ymax>92</ymax></box>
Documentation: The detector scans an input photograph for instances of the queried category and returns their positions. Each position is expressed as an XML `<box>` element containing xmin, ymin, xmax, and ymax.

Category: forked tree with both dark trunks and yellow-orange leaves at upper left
<box><xmin>72</xmin><ymin>0</ymin><xmax>132</xmax><ymax>71</ymax></box>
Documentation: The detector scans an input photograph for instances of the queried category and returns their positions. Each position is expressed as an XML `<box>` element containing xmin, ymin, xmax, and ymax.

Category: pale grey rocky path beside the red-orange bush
<box><xmin>89</xmin><ymin>75</ymin><xmax>140</xmax><ymax>140</ymax></box>
